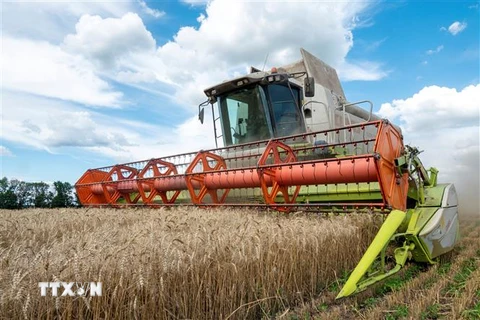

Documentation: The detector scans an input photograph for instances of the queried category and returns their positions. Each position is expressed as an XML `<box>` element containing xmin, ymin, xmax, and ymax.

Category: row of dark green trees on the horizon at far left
<box><xmin>0</xmin><ymin>177</ymin><xmax>79</xmax><ymax>209</ymax></box>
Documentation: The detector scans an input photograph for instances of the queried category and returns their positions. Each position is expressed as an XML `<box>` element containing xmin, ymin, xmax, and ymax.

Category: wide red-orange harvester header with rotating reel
<box><xmin>76</xmin><ymin>120</ymin><xmax>408</xmax><ymax>211</ymax></box>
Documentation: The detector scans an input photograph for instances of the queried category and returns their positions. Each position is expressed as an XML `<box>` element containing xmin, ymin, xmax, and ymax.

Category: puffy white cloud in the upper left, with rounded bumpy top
<box><xmin>64</xmin><ymin>13</ymin><xmax>155</xmax><ymax>66</ymax></box>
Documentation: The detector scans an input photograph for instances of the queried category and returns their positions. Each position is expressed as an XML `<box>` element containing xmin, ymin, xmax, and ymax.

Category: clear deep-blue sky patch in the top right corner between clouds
<box><xmin>344</xmin><ymin>1</ymin><xmax>479</xmax><ymax>106</ymax></box>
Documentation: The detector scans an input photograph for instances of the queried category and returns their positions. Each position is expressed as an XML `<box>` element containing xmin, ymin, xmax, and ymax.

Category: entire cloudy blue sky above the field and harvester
<box><xmin>0</xmin><ymin>0</ymin><xmax>480</xmax><ymax>209</ymax></box>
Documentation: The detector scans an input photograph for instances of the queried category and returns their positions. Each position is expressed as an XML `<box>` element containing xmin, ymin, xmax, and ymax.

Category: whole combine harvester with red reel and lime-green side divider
<box><xmin>75</xmin><ymin>49</ymin><xmax>459</xmax><ymax>298</ymax></box>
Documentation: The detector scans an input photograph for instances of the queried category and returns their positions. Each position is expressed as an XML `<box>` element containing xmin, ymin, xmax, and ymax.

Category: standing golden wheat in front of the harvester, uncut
<box><xmin>0</xmin><ymin>208</ymin><xmax>382</xmax><ymax>319</ymax></box>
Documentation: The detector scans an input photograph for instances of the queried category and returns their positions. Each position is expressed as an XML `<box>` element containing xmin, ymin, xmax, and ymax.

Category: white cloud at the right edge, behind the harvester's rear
<box><xmin>379</xmin><ymin>84</ymin><xmax>480</xmax><ymax>209</ymax></box>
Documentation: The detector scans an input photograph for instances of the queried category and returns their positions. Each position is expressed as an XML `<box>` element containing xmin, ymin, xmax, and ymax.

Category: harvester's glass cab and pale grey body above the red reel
<box><xmin>199</xmin><ymin>49</ymin><xmax>380</xmax><ymax>147</ymax></box>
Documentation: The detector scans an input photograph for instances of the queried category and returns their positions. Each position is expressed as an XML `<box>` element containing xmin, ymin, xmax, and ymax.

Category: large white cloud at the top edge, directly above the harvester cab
<box><xmin>159</xmin><ymin>0</ymin><xmax>358</xmax><ymax>69</ymax></box>
